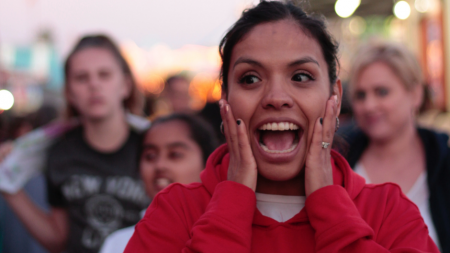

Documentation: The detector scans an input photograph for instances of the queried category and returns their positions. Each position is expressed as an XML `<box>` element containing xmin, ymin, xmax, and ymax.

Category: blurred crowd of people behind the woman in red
<box><xmin>0</xmin><ymin>0</ymin><xmax>450</xmax><ymax>253</ymax></box>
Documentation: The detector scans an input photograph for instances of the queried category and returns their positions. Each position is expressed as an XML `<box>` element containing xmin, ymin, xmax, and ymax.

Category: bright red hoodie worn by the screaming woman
<box><xmin>125</xmin><ymin>145</ymin><xmax>439</xmax><ymax>253</ymax></box>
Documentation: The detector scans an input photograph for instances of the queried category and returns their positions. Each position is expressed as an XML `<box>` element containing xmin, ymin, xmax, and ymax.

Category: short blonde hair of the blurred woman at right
<box><xmin>349</xmin><ymin>42</ymin><xmax>423</xmax><ymax>93</ymax></box>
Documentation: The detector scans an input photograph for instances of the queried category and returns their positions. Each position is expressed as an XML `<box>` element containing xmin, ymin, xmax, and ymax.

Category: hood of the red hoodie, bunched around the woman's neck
<box><xmin>200</xmin><ymin>144</ymin><xmax>366</xmax><ymax>225</ymax></box>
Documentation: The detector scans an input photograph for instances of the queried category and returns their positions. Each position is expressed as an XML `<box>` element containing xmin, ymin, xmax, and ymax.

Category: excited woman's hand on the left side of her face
<box><xmin>219</xmin><ymin>100</ymin><xmax>258</xmax><ymax>191</ymax></box>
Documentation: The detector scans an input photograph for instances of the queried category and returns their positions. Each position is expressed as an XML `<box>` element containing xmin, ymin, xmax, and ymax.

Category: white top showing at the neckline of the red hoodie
<box><xmin>256</xmin><ymin>192</ymin><xmax>306</xmax><ymax>222</ymax></box>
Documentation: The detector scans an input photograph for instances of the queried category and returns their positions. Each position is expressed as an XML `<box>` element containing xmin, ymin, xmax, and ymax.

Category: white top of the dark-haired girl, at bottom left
<box><xmin>99</xmin><ymin>210</ymin><xmax>145</xmax><ymax>253</ymax></box>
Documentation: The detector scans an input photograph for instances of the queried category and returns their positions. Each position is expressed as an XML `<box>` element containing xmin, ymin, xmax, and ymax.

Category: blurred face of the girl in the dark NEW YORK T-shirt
<box><xmin>66</xmin><ymin>48</ymin><xmax>131</xmax><ymax>119</ymax></box>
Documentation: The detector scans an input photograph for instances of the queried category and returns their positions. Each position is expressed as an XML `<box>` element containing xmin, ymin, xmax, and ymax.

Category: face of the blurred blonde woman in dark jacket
<box><xmin>352</xmin><ymin>62</ymin><xmax>421</xmax><ymax>141</ymax></box>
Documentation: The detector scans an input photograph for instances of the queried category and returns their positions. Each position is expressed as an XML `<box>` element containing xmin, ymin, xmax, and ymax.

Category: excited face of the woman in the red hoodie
<box><xmin>222</xmin><ymin>20</ymin><xmax>341</xmax><ymax>181</ymax></box>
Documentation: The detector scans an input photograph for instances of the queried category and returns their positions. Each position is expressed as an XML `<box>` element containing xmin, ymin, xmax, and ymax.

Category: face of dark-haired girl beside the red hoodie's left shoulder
<box><xmin>140</xmin><ymin>120</ymin><xmax>203</xmax><ymax>198</ymax></box>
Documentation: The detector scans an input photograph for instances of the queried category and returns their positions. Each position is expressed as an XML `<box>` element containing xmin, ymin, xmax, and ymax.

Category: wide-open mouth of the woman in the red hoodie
<box><xmin>258</xmin><ymin>122</ymin><xmax>303</xmax><ymax>154</ymax></box>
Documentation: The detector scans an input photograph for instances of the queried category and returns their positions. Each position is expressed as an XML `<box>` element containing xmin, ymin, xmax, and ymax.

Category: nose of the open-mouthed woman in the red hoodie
<box><xmin>261</xmin><ymin>82</ymin><xmax>294</xmax><ymax>110</ymax></box>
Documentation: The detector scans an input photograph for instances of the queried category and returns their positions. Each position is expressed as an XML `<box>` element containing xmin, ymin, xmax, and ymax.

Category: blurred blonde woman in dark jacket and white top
<box><xmin>347</xmin><ymin>42</ymin><xmax>450</xmax><ymax>252</ymax></box>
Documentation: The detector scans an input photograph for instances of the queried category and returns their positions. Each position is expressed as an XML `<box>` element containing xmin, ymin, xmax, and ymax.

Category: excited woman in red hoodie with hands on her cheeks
<box><xmin>125</xmin><ymin>1</ymin><xmax>439</xmax><ymax>253</ymax></box>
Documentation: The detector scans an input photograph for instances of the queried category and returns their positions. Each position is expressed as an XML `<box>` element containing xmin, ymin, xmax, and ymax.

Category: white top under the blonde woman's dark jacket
<box><xmin>355</xmin><ymin>163</ymin><xmax>439</xmax><ymax>247</ymax></box>
